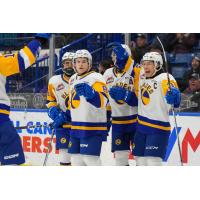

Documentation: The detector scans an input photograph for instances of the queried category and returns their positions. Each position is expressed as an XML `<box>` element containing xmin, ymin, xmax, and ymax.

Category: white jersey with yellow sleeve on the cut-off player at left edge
<box><xmin>0</xmin><ymin>41</ymin><xmax>40</xmax><ymax>121</ymax></box>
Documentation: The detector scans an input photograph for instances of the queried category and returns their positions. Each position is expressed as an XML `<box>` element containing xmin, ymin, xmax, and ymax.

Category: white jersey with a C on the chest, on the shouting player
<box><xmin>138</xmin><ymin>69</ymin><xmax>178</xmax><ymax>134</ymax></box>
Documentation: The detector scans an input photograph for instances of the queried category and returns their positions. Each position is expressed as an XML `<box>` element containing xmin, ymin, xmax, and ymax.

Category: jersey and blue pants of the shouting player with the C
<box><xmin>133</xmin><ymin>68</ymin><xmax>178</xmax><ymax>158</ymax></box>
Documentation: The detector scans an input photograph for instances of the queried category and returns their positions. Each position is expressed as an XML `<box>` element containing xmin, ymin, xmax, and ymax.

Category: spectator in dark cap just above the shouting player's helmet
<box><xmin>131</xmin><ymin>33</ymin><xmax>148</xmax><ymax>63</ymax></box>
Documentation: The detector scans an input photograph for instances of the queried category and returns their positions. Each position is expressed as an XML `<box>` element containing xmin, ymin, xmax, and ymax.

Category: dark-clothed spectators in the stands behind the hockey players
<box><xmin>98</xmin><ymin>33</ymin><xmax>200</xmax><ymax>112</ymax></box>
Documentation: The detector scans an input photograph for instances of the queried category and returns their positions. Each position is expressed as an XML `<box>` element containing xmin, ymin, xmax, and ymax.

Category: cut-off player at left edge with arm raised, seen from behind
<box><xmin>0</xmin><ymin>34</ymin><xmax>49</xmax><ymax>165</ymax></box>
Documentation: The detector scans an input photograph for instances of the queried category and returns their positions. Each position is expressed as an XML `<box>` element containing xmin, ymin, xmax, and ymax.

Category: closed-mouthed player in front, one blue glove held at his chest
<box><xmin>69</xmin><ymin>49</ymin><xmax>108</xmax><ymax>166</ymax></box>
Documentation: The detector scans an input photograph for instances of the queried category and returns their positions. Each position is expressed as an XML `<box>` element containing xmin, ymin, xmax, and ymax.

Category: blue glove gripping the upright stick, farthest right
<box><xmin>165</xmin><ymin>87</ymin><xmax>181</xmax><ymax>108</ymax></box>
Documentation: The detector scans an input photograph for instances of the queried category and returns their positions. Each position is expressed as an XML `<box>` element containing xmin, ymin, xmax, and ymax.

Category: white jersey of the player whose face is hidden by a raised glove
<box><xmin>103</xmin><ymin>57</ymin><xmax>137</xmax><ymax>132</ymax></box>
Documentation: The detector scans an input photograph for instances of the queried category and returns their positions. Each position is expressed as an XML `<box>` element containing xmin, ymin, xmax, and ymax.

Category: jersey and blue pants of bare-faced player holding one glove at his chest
<box><xmin>69</xmin><ymin>71</ymin><xmax>108</xmax><ymax>156</ymax></box>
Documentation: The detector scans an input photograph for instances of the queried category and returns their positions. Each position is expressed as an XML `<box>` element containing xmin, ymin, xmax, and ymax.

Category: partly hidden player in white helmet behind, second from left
<box><xmin>47</xmin><ymin>52</ymin><xmax>74</xmax><ymax>165</ymax></box>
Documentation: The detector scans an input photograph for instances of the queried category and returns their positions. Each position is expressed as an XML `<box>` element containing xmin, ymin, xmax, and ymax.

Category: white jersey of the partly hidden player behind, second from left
<box><xmin>46</xmin><ymin>74</ymin><xmax>71</xmax><ymax>129</ymax></box>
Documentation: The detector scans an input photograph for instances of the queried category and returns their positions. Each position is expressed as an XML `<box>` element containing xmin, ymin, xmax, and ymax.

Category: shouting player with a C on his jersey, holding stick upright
<box><xmin>133</xmin><ymin>52</ymin><xmax>181</xmax><ymax>166</ymax></box>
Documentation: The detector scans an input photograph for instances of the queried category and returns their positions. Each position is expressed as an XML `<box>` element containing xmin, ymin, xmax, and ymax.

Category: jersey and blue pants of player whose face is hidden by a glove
<box><xmin>103</xmin><ymin>56</ymin><xmax>137</xmax><ymax>152</ymax></box>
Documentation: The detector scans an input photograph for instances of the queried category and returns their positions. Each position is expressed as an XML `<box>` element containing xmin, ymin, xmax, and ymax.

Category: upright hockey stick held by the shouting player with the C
<box><xmin>157</xmin><ymin>36</ymin><xmax>183</xmax><ymax>166</ymax></box>
